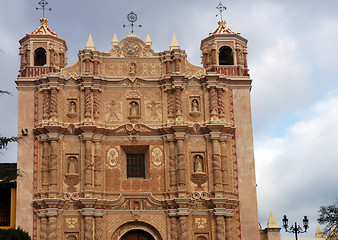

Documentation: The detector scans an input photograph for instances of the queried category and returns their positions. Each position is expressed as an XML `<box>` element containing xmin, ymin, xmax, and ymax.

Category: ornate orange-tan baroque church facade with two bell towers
<box><xmin>16</xmin><ymin>15</ymin><xmax>259</xmax><ymax>240</ymax></box>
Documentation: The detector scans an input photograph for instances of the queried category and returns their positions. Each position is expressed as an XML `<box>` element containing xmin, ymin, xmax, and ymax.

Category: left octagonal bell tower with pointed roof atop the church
<box><xmin>19</xmin><ymin>18</ymin><xmax>67</xmax><ymax>77</ymax></box>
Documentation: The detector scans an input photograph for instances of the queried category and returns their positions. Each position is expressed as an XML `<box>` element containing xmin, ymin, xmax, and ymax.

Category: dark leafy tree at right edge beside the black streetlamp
<box><xmin>317</xmin><ymin>199</ymin><xmax>338</xmax><ymax>240</ymax></box>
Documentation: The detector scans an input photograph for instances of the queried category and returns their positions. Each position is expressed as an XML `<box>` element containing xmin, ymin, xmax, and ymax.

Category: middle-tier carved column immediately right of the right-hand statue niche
<box><xmin>210</xmin><ymin>133</ymin><xmax>222</xmax><ymax>192</ymax></box>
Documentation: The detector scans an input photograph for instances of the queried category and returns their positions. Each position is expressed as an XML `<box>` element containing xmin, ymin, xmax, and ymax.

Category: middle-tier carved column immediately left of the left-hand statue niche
<box><xmin>49</xmin><ymin>139</ymin><xmax>59</xmax><ymax>198</ymax></box>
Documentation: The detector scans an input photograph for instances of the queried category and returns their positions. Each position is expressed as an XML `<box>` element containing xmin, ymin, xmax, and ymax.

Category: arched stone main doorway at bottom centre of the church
<box><xmin>111</xmin><ymin>221</ymin><xmax>163</xmax><ymax>240</ymax></box>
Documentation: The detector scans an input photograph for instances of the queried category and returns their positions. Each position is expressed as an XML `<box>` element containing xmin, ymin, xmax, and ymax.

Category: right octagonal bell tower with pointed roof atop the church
<box><xmin>201</xmin><ymin>20</ymin><xmax>249</xmax><ymax>76</ymax></box>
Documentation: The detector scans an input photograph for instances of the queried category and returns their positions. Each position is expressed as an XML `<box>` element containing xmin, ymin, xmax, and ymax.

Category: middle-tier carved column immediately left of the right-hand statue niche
<box><xmin>175</xmin><ymin>133</ymin><xmax>185</xmax><ymax>191</ymax></box>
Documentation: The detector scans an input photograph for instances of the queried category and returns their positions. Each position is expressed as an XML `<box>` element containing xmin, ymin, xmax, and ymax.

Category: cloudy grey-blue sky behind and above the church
<box><xmin>0</xmin><ymin>0</ymin><xmax>338</xmax><ymax>237</ymax></box>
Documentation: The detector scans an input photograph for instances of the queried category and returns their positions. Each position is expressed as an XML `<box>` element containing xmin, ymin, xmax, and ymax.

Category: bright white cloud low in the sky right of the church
<box><xmin>255</xmin><ymin>90</ymin><xmax>338</xmax><ymax>236</ymax></box>
